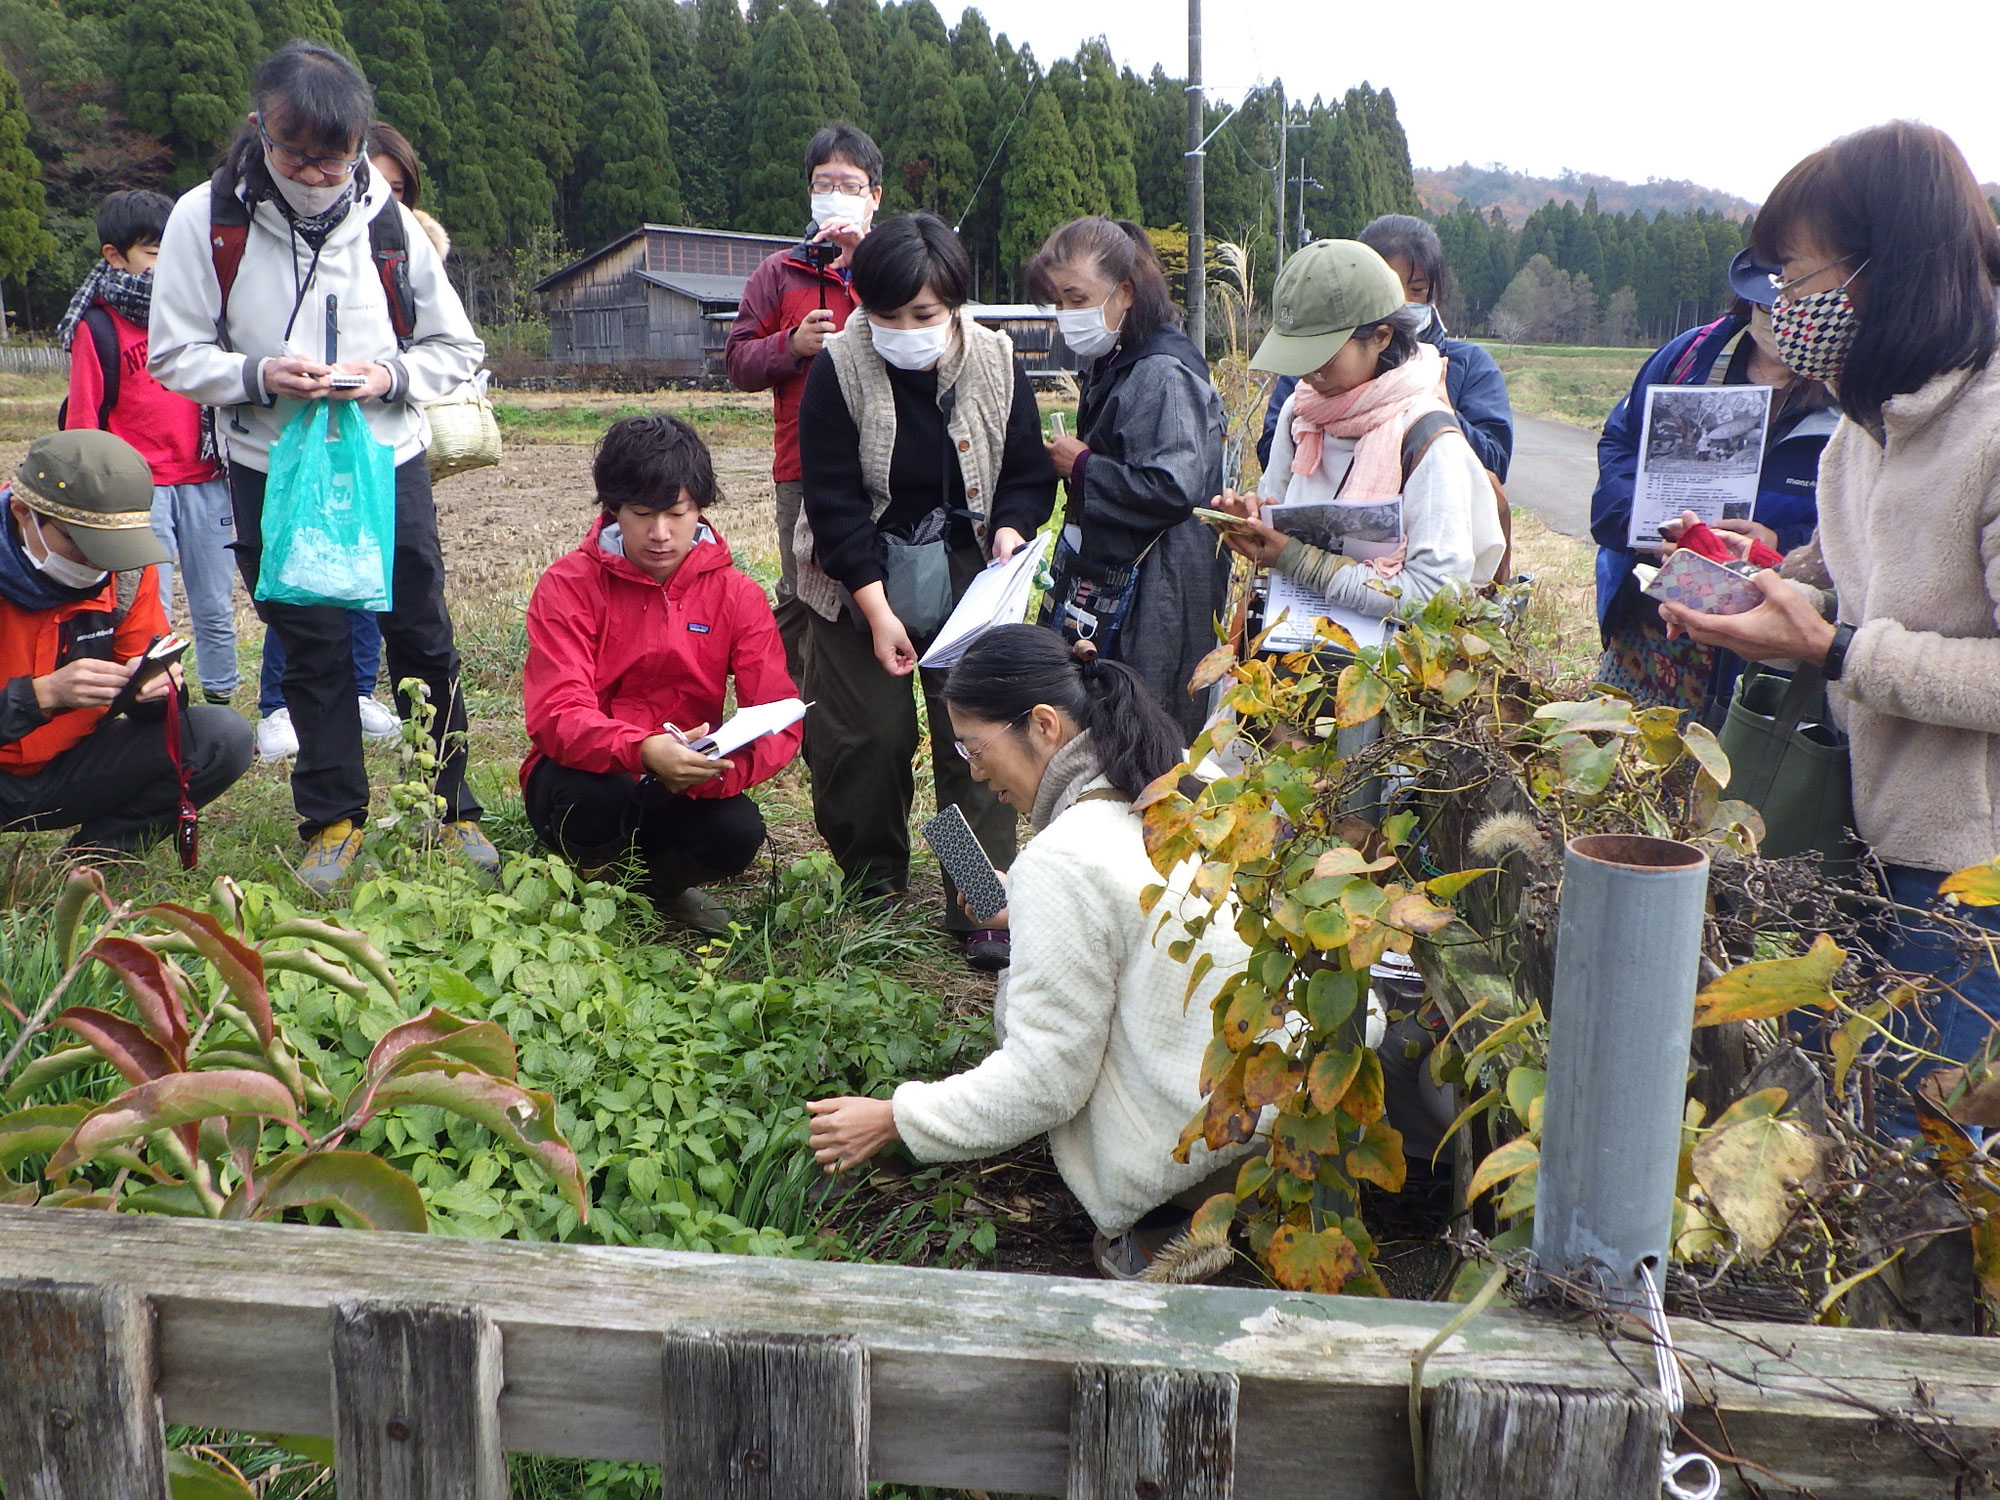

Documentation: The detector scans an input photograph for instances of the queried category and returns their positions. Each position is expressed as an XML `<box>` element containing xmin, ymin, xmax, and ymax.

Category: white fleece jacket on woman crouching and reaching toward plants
<box><xmin>894</xmin><ymin>736</ymin><xmax>1248</xmax><ymax>1234</ymax></box>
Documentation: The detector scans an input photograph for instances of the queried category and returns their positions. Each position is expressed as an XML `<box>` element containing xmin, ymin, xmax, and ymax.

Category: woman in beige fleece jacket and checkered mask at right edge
<box><xmin>1662</xmin><ymin>122</ymin><xmax>2000</xmax><ymax>1134</ymax></box>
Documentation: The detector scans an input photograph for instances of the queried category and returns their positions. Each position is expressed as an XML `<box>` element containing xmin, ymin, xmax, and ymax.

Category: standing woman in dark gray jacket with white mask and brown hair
<box><xmin>1028</xmin><ymin>218</ymin><xmax>1230</xmax><ymax>740</ymax></box>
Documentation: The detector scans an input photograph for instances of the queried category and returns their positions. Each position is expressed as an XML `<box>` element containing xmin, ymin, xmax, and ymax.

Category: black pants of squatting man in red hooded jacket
<box><xmin>524</xmin><ymin>760</ymin><xmax>764</xmax><ymax>898</ymax></box>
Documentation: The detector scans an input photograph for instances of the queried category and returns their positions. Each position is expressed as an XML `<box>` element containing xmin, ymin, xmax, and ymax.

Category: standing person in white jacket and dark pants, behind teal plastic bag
<box><xmin>148</xmin><ymin>42</ymin><xmax>498</xmax><ymax>894</ymax></box>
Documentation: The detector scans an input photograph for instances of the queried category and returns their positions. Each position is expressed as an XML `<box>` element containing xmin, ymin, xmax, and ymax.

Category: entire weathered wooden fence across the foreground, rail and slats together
<box><xmin>0</xmin><ymin>1208</ymin><xmax>2000</xmax><ymax>1500</ymax></box>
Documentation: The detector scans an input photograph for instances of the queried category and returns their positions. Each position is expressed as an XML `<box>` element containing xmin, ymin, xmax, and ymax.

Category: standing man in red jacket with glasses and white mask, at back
<box><xmin>722</xmin><ymin>120</ymin><xmax>882</xmax><ymax>678</ymax></box>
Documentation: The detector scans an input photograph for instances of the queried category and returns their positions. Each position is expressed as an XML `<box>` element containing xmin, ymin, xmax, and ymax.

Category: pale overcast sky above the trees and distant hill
<box><xmin>976</xmin><ymin>0</ymin><xmax>2000</xmax><ymax>200</ymax></box>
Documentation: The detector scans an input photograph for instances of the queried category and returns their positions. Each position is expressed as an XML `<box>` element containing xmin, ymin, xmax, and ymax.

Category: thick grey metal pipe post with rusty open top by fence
<box><xmin>1534</xmin><ymin>834</ymin><xmax>1708</xmax><ymax>1306</ymax></box>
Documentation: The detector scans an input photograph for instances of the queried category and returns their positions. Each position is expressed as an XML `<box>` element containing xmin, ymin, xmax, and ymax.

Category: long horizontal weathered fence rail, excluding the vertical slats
<box><xmin>0</xmin><ymin>1208</ymin><xmax>2000</xmax><ymax>1500</ymax></box>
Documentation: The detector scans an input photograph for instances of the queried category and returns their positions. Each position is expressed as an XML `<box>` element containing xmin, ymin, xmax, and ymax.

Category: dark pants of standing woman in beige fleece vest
<box><xmin>806</xmin><ymin>548</ymin><xmax>1014</xmax><ymax>932</ymax></box>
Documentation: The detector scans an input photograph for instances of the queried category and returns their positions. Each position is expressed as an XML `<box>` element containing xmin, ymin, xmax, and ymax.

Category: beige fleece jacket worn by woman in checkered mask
<box><xmin>1820</xmin><ymin>360</ymin><xmax>2000</xmax><ymax>870</ymax></box>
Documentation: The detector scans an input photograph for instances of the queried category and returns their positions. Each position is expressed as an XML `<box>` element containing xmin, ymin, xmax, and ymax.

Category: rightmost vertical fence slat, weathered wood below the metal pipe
<box><xmin>1424</xmin><ymin>1380</ymin><xmax>1666</xmax><ymax>1500</ymax></box>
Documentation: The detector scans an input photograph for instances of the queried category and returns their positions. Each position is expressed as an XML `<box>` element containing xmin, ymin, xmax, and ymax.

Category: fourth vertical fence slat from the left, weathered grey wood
<box><xmin>1068</xmin><ymin>1364</ymin><xmax>1236</xmax><ymax>1500</ymax></box>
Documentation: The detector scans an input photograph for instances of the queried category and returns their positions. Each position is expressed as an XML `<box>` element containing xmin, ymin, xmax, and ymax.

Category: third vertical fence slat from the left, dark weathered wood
<box><xmin>660</xmin><ymin>1328</ymin><xmax>868</xmax><ymax>1500</ymax></box>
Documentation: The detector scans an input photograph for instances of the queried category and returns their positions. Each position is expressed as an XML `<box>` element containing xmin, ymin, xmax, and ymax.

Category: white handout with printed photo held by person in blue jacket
<box><xmin>1626</xmin><ymin>386</ymin><xmax>1770</xmax><ymax>548</ymax></box>
